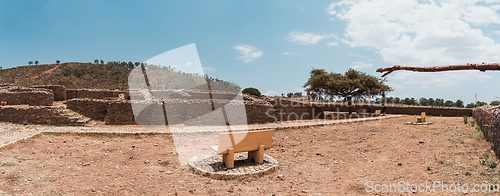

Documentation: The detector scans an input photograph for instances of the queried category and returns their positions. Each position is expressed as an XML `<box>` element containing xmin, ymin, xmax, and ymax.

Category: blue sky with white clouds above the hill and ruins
<box><xmin>0</xmin><ymin>0</ymin><xmax>500</xmax><ymax>103</ymax></box>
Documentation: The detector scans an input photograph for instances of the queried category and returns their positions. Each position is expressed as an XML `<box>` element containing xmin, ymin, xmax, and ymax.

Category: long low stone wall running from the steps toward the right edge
<box><xmin>68</xmin><ymin>98</ymin><xmax>472</xmax><ymax>125</ymax></box>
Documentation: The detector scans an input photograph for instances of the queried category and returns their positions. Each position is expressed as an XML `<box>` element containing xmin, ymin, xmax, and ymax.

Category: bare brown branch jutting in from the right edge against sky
<box><xmin>377</xmin><ymin>63</ymin><xmax>500</xmax><ymax>77</ymax></box>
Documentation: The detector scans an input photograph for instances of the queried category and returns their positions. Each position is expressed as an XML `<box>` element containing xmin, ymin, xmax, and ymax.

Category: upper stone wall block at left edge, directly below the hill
<box><xmin>0</xmin><ymin>88</ymin><xmax>54</xmax><ymax>106</ymax></box>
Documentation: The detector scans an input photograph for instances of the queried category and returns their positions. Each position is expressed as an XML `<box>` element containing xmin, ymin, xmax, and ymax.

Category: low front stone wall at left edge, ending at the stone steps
<box><xmin>0</xmin><ymin>106</ymin><xmax>73</xmax><ymax>125</ymax></box>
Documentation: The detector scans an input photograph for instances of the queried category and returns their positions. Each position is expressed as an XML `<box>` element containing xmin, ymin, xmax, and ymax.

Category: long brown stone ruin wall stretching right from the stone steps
<box><xmin>68</xmin><ymin>92</ymin><xmax>472</xmax><ymax>125</ymax></box>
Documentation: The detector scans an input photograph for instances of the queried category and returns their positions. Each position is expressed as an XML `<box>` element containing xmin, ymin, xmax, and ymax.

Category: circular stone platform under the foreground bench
<box><xmin>189</xmin><ymin>153</ymin><xmax>278</xmax><ymax>180</ymax></box>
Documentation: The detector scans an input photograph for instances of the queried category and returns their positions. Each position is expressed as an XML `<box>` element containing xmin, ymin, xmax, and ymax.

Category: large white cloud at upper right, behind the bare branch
<box><xmin>327</xmin><ymin>0</ymin><xmax>500</xmax><ymax>86</ymax></box>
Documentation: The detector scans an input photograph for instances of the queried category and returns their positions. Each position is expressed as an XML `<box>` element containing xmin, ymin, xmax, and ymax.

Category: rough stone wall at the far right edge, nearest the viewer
<box><xmin>472</xmin><ymin>106</ymin><xmax>500</xmax><ymax>156</ymax></box>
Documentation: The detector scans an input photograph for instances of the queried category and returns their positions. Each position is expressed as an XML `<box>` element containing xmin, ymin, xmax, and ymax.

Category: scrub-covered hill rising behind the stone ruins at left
<box><xmin>0</xmin><ymin>62</ymin><xmax>240</xmax><ymax>91</ymax></box>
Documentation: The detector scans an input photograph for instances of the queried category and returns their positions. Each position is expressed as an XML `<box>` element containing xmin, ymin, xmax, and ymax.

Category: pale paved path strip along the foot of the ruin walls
<box><xmin>0</xmin><ymin>115</ymin><xmax>403</xmax><ymax>148</ymax></box>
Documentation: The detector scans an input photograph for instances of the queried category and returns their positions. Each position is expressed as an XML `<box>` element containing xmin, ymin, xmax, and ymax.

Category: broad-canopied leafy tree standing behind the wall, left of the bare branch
<box><xmin>304</xmin><ymin>69</ymin><xmax>392</xmax><ymax>113</ymax></box>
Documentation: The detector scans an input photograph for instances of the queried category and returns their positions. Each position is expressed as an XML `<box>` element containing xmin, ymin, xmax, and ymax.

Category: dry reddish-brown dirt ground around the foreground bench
<box><xmin>0</xmin><ymin>116</ymin><xmax>500</xmax><ymax>195</ymax></box>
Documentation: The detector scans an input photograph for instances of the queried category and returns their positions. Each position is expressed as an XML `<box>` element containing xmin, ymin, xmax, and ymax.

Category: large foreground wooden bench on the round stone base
<box><xmin>210</xmin><ymin>129</ymin><xmax>274</xmax><ymax>168</ymax></box>
